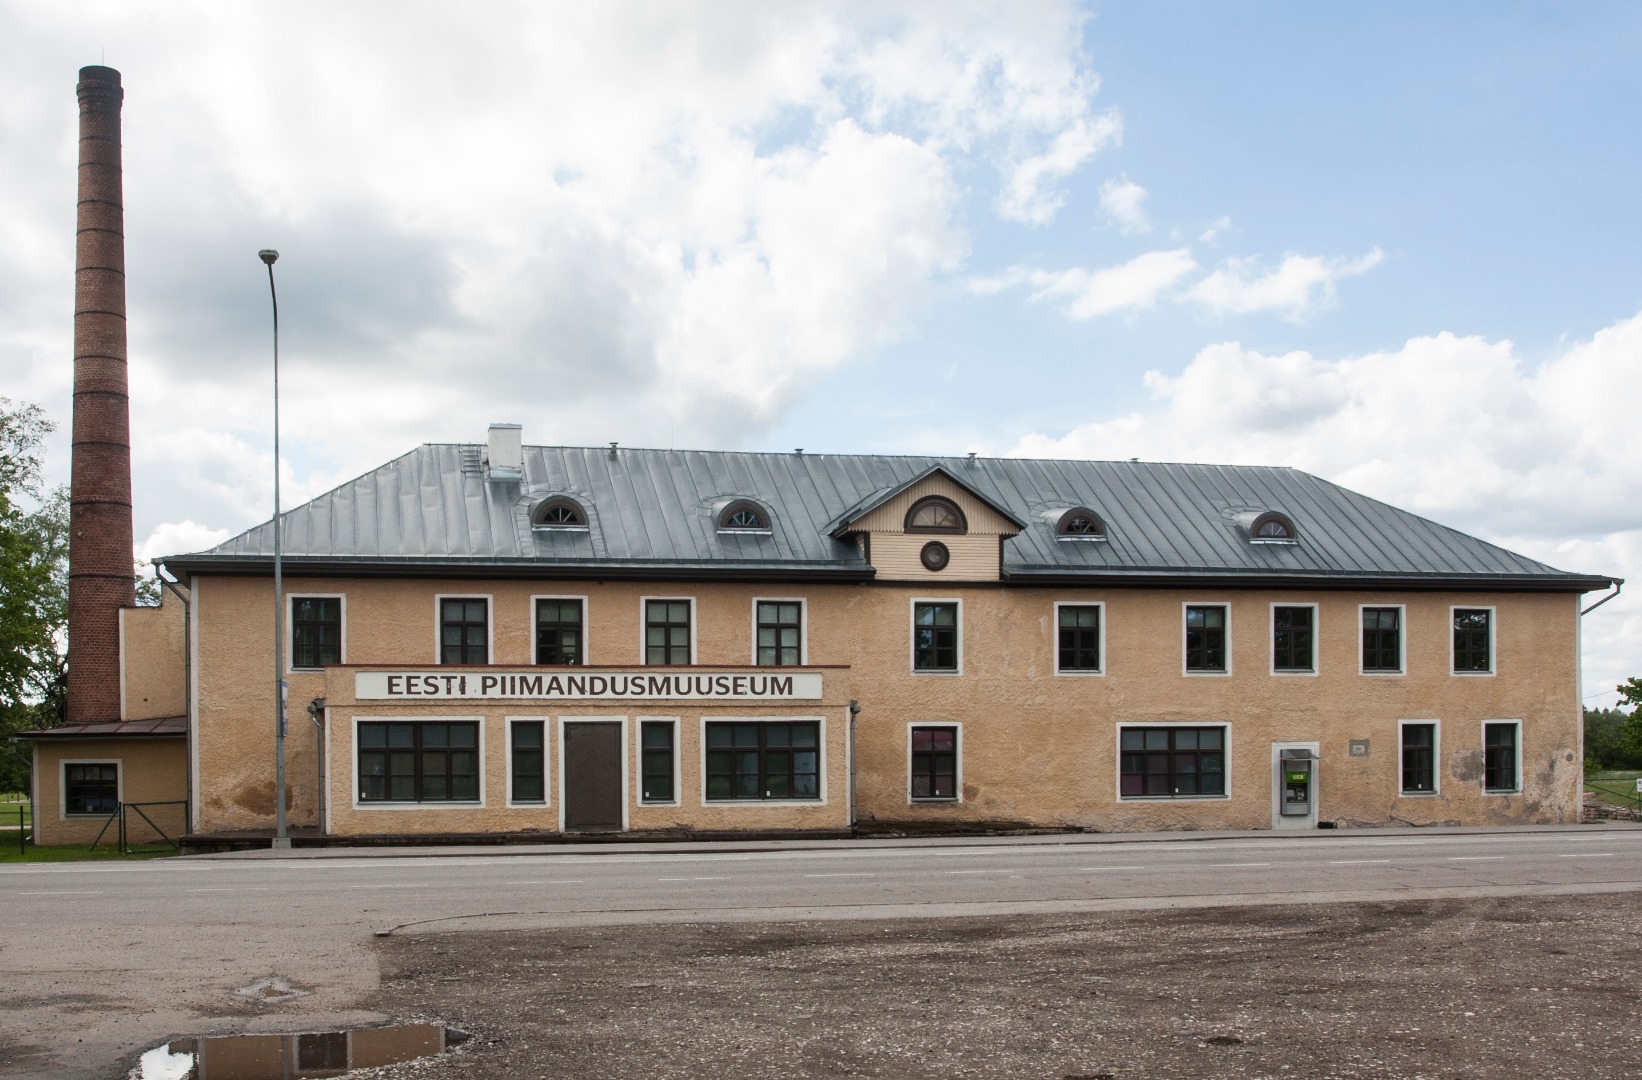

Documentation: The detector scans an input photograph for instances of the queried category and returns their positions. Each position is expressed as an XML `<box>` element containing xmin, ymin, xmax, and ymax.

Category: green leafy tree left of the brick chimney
<box><xmin>0</xmin><ymin>397</ymin><xmax>69</xmax><ymax>791</ymax></box>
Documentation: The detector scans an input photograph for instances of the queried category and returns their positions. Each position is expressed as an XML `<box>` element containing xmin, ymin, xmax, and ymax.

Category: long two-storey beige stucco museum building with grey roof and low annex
<box><xmin>25</xmin><ymin>425</ymin><xmax>1614</xmax><ymax>842</ymax></box>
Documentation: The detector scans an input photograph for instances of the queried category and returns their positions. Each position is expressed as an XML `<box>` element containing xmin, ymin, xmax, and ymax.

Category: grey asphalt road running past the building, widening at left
<box><xmin>0</xmin><ymin>827</ymin><xmax>1642</xmax><ymax>1077</ymax></box>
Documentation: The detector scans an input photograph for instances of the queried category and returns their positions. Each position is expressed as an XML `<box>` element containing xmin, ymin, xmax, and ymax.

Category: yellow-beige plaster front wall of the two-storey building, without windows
<box><xmin>186</xmin><ymin>567</ymin><xmax>1580</xmax><ymax>831</ymax></box>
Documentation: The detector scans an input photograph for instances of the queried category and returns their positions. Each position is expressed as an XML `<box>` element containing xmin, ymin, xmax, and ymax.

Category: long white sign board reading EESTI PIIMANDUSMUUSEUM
<box><xmin>353</xmin><ymin>671</ymin><xmax>821</xmax><ymax>701</ymax></box>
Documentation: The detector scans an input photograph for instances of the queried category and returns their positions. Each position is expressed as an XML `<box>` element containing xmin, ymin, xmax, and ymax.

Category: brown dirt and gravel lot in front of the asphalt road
<box><xmin>346</xmin><ymin>893</ymin><xmax>1642</xmax><ymax>1080</ymax></box>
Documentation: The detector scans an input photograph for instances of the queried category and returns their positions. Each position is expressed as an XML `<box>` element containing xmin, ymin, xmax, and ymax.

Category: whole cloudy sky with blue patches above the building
<box><xmin>0</xmin><ymin>0</ymin><xmax>1642</xmax><ymax>704</ymax></box>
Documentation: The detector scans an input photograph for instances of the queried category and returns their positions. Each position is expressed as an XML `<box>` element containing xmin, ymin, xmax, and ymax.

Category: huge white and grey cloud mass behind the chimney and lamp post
<box><xmin>0</xmin><ymin>0</ymin><xmax>1121</xmax><ymax>533</ymax></box>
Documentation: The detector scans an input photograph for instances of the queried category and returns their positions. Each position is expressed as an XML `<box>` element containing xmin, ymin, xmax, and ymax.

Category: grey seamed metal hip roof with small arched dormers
<box><xmin>163</xmin><ymin>443</ymin><xmax>1611</xmax><ymax>591</ymax></box>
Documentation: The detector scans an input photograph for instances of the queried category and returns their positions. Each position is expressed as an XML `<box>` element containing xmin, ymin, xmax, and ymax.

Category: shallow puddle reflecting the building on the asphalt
<box><xmin>126</xmin><ymin>1024</ymin><xmax>468</xmax><ymax>1080</ymax></box>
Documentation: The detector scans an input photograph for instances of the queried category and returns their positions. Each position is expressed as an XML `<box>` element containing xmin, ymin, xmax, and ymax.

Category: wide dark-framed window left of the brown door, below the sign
<box><xmin>360</xmin><ymin>721</ymin><xmax>479</xmax><ymax>803</ymax></box>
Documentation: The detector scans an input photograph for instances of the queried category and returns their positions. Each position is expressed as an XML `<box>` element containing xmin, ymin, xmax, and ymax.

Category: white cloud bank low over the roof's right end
<box><xmin>1011</xmin><ymin>308</ymin><xmax>1642</xmax><ymax>693</ymax></box>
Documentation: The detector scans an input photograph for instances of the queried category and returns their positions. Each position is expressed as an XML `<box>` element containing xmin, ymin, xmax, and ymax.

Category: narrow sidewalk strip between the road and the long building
<box><xmin>192</xmin><ymin>822</ymin><xmax>1642</xmax><ymax>860</ymax></box>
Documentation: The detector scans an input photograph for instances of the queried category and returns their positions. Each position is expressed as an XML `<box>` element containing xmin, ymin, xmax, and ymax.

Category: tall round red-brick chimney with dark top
<box><xmin>67</xmin><ymin>67</ymin><xmax>136</xmax><ymax>724</ymax></box>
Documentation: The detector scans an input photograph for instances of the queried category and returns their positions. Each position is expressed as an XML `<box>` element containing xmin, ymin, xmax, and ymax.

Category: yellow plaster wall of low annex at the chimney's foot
<box><xmin>34</xmin><ymin>739</ymin><xmax>187</xmax><ymax>845</ymax></box>
